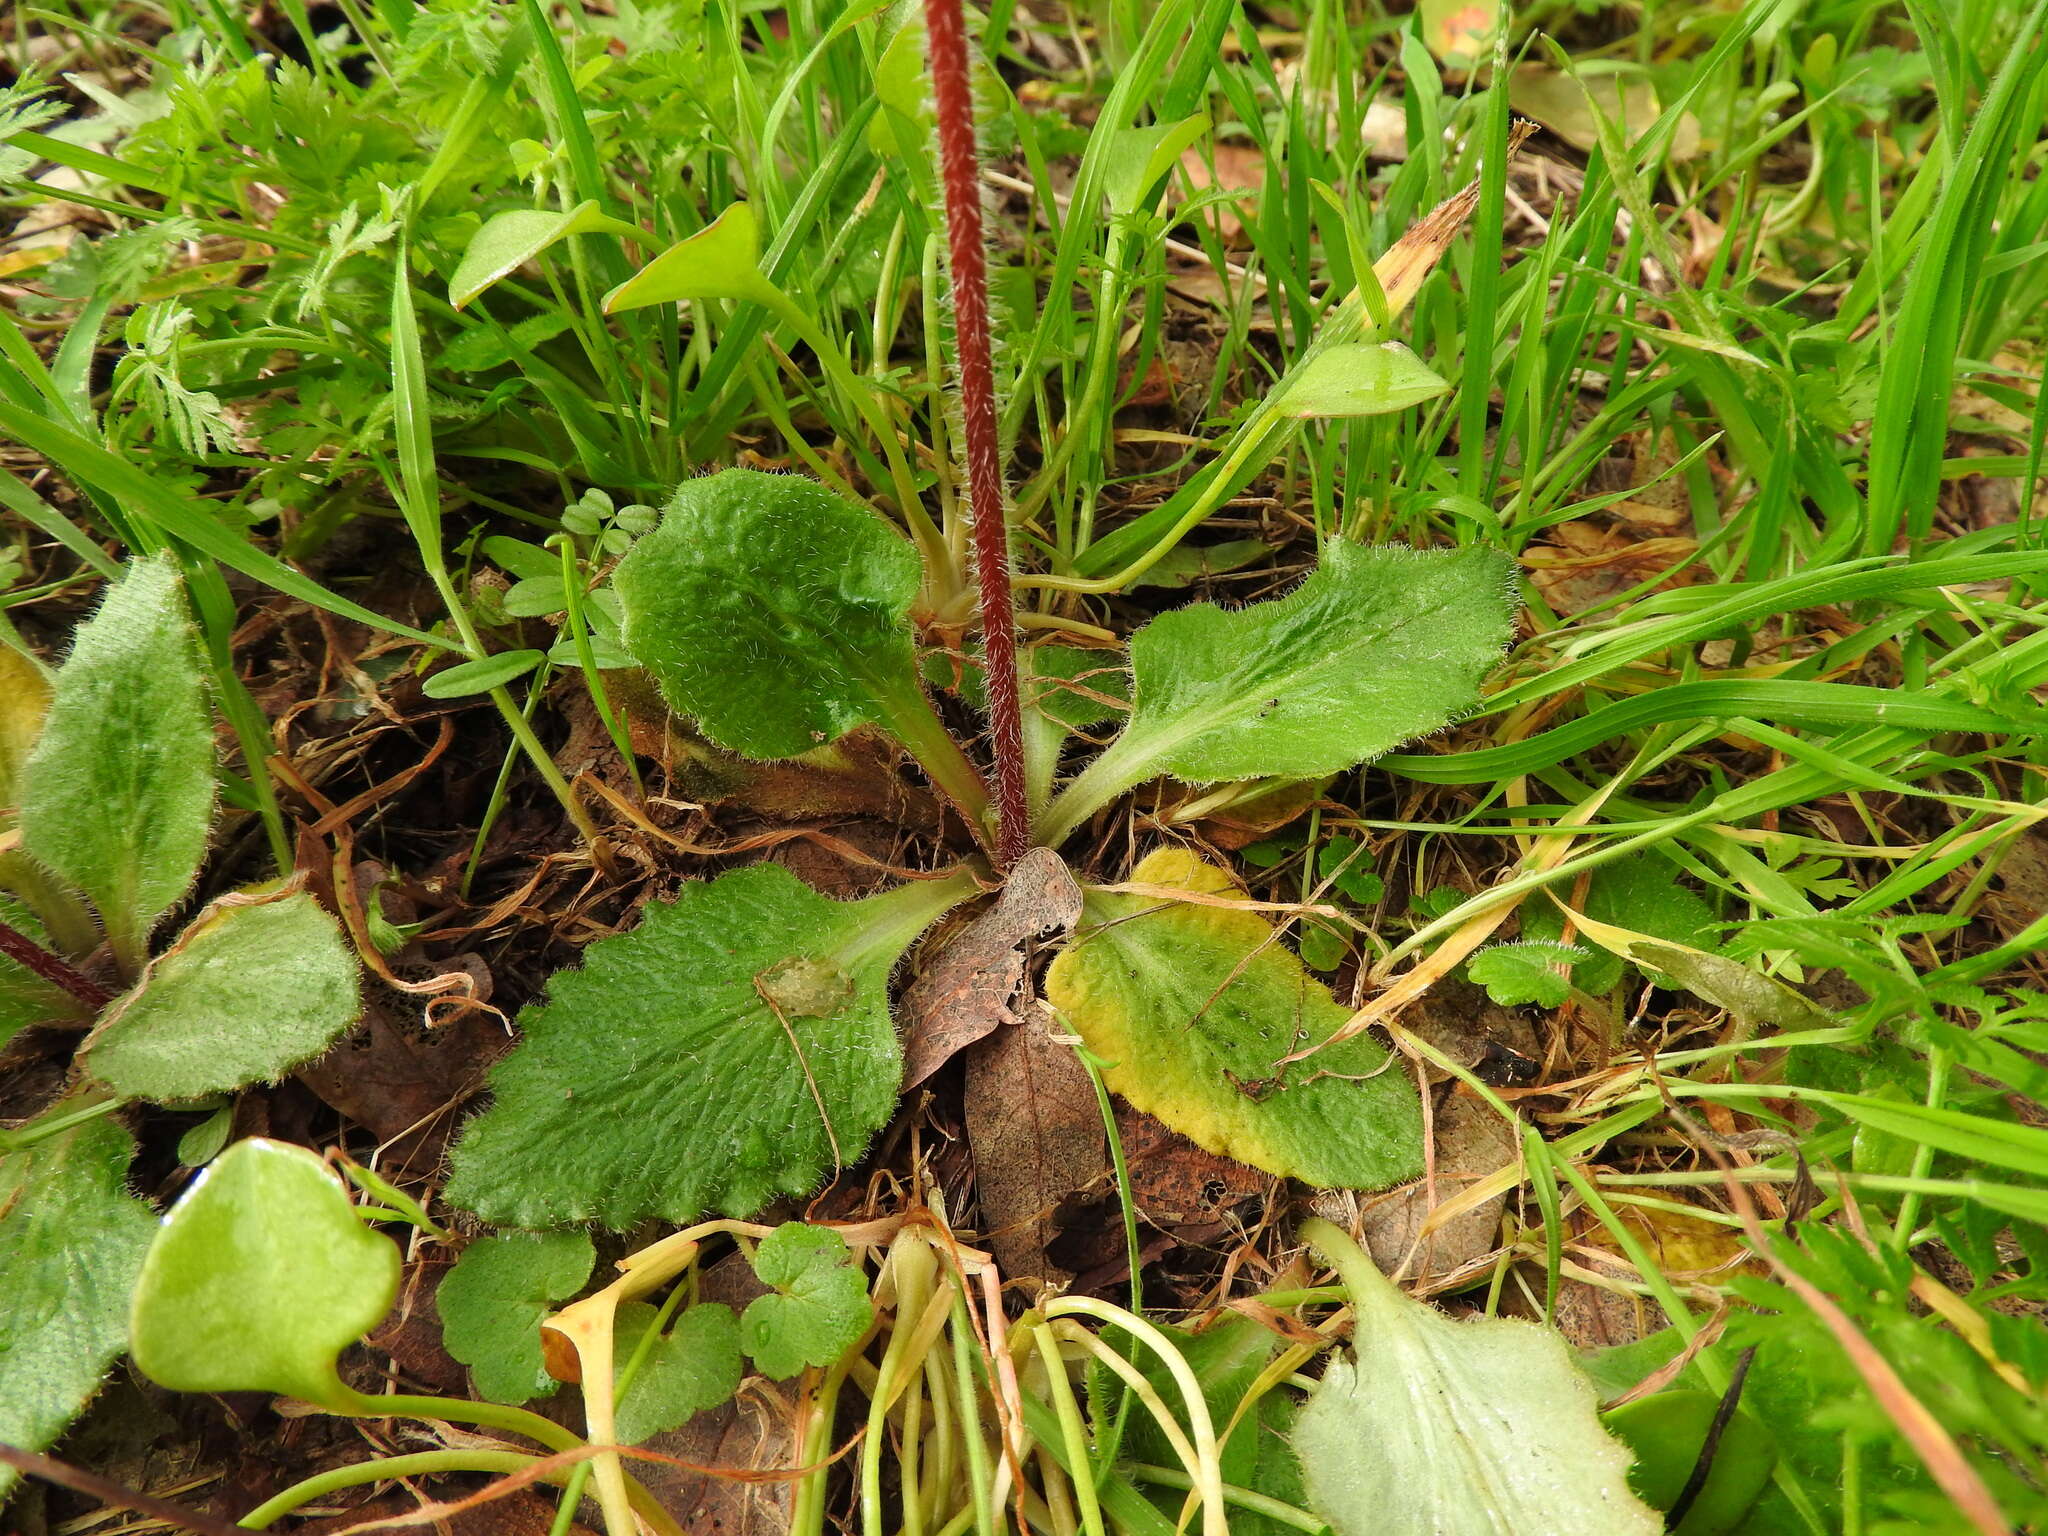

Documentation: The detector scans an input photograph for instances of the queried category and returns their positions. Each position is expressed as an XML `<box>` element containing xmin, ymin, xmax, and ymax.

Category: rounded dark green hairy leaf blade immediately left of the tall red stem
<box><xmin>612</xmin><ymin>469</ymin><xmax>926</xmax><ymax>758</ymax></box>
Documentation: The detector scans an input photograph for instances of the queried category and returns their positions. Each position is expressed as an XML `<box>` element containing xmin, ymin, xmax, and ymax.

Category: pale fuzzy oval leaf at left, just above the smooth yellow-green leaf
<box><xmin>84</xmin><ymin>891</ymin><xmax>360</xmax><ymax>1102</ymax></box>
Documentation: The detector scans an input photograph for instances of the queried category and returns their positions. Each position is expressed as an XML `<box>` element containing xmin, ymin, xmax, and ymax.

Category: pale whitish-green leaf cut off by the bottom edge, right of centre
<box><xmin>1294</xmin><ymin>1221</ymin><xmax>1663</xmax><ymax>1536</ymax></box>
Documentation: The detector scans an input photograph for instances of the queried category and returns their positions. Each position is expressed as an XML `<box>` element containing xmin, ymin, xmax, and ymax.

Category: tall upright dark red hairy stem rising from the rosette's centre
<box><xmin>924</xmin><ymin>0</ymin><xmax>1030</xmax><ymax>868</ymax></box>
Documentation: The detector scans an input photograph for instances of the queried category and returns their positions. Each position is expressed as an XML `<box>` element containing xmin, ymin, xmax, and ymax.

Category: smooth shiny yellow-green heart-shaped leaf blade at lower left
<box><xmin>129</xmin><ymin>1139</ymin><xmax>399</xmax><ymax>1413</ymax></box>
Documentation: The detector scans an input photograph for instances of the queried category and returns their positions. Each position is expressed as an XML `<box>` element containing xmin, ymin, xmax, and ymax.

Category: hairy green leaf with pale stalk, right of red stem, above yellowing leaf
<box><xmin>1042</xmin><ymin>541</ymin><xmax>1516</xmax><ymax>844</ymax></box>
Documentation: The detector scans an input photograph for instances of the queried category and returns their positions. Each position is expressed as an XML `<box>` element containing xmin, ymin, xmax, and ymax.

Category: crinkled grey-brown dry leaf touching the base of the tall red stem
<box><xmin>903</xmin><ymin>848</ymin><xmax>1081</xmax><ymax>1092</ymax></box>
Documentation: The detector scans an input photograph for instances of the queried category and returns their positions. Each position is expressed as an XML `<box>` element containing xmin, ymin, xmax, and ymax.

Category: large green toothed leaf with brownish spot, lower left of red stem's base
<box><xmin>449</xmin><ymin>864</ymin><xmax>973</xmax><ymax>1229</ymax></box>
